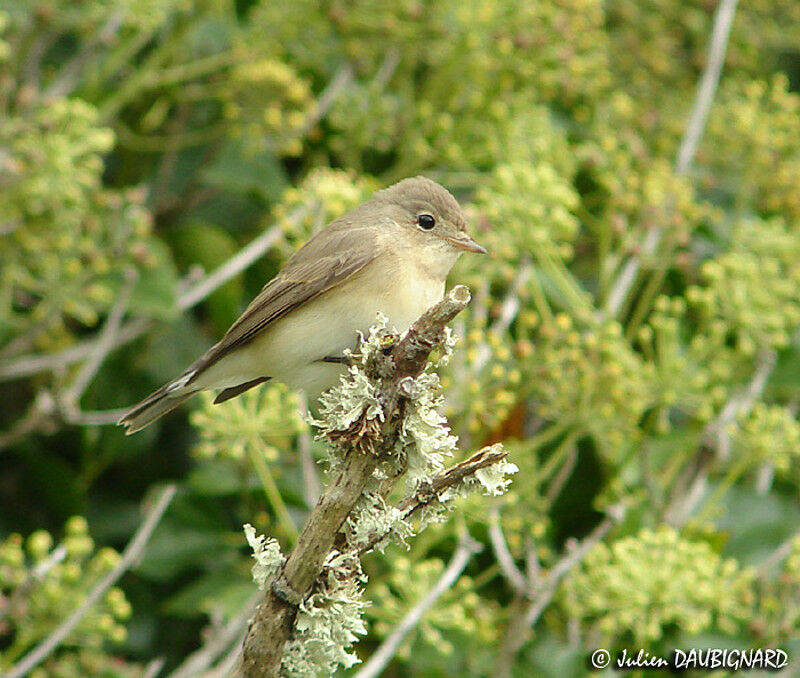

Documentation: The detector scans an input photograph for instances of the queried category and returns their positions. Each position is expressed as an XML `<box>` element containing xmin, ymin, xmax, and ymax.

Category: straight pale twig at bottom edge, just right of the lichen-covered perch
<box><xmin>353</xmin><ymin>532</ymin><xmax>481</xmax><ymax>678</ymax></box>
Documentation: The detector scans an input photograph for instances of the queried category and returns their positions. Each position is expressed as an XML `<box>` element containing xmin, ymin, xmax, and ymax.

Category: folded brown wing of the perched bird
<box><xmin>189</xmin><ymin>220</ymin><xmax>382</xmax><ymax>383</ymax></box>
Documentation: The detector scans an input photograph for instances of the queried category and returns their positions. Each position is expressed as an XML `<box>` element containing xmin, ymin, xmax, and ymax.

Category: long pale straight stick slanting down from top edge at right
<box><xmin>605</xmin><ymin>0</ymin><xmax>738</xmax><ymax>317</ymax></box>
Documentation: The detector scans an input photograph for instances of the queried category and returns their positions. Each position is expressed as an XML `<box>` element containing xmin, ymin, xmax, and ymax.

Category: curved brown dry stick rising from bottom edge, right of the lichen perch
<box><xmin>496</xmin><ymin>504</ymin><xmax>627</xmax><ymax>678</ymax></box>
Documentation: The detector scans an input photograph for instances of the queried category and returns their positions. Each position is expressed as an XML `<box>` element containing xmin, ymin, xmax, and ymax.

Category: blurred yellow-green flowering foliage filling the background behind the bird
<box><xmin>0</xmin><ymin>0</ymin><xmax>800</xmax><ymax>678</ymax></box>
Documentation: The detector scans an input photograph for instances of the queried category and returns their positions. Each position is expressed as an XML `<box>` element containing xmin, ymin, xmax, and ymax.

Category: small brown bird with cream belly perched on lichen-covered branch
<box><xmin>118</xmin><ymin>176</ymin><xmax>486</xmax><ymax>434</ymax></box>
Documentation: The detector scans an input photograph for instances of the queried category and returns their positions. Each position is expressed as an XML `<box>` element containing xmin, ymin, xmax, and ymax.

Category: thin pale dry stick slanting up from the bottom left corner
<box><xmin>5</xmin><ymin>485</ymin><xmax>175</xmax><ymax>678</ymax></box>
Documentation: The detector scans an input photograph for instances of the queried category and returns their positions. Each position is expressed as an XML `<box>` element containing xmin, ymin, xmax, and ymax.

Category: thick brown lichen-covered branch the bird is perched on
<box><xmin>237</xmin><ymin>286</ymin><xmax>470</xmax><ymax>678</ymax></box>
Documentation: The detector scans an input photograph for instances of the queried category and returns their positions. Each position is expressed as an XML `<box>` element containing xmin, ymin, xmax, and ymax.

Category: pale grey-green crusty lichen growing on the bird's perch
<box><xmin>245</xmin><ymin>314</ymin><xmax>517</xmax><ymax>677</ymax></box>
